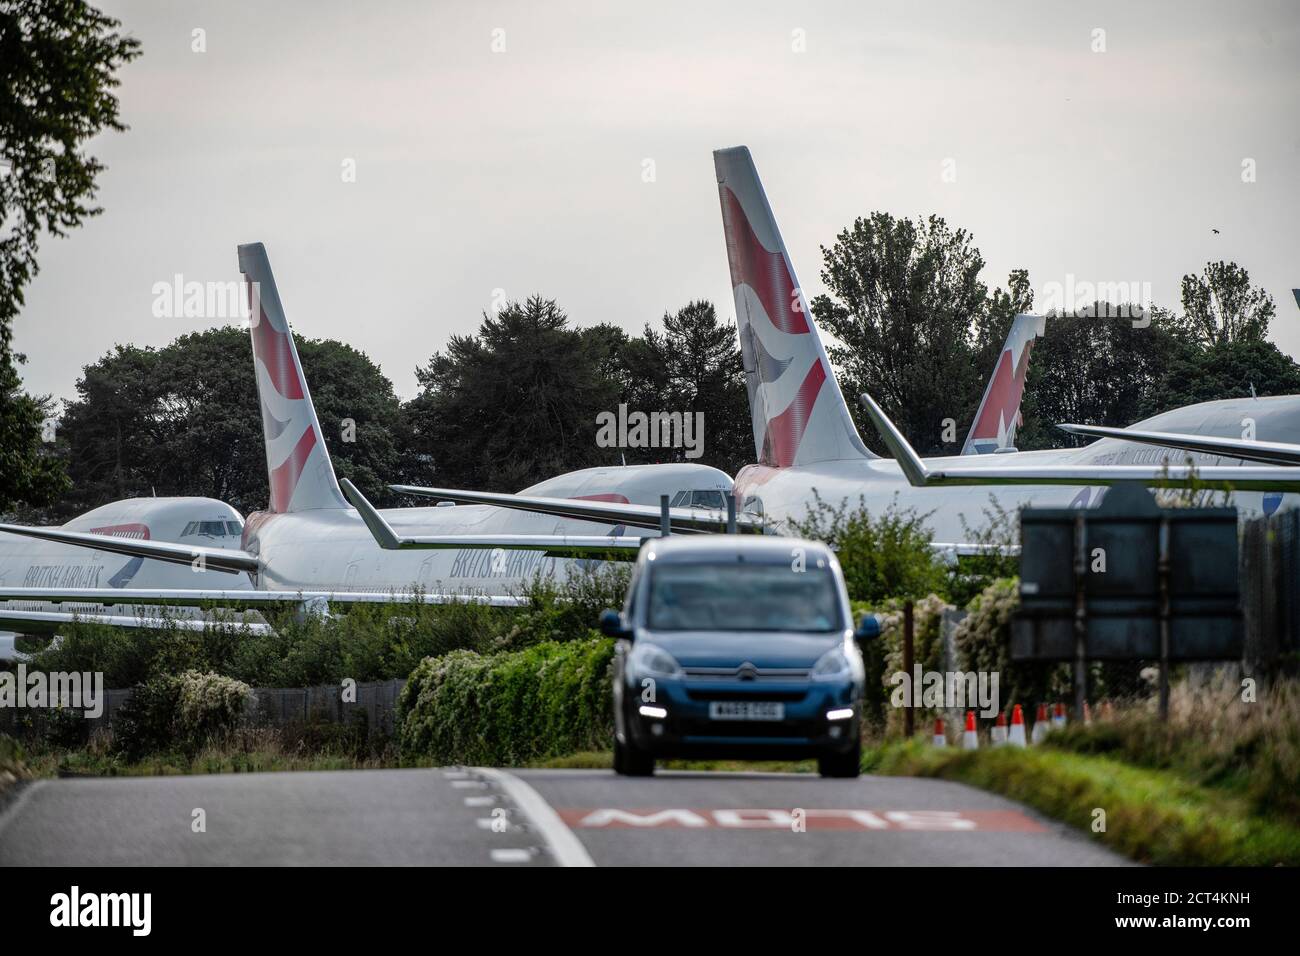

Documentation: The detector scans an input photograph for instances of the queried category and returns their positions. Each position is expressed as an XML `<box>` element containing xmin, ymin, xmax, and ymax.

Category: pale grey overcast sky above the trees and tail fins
<box><xmin>16</xmin><ymin>0</ymin><xmax>1300</xmax><ymax>401</ymax></box>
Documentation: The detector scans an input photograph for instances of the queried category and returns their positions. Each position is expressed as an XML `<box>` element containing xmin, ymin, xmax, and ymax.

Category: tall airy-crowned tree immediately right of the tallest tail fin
<box><xmin>813</xmin><ymin>212</ymin><xmax>1005</xmax><ymax>453</ymax></box>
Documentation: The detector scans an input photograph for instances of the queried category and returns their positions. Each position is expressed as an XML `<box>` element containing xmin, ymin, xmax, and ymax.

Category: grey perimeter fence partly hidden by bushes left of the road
<box><xmin>0</xmin><ymin>679</ymin><xmax>406</xmax><ymax>739</ymax></box>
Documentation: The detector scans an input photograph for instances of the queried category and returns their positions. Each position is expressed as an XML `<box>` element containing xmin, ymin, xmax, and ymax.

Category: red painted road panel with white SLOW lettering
<box><xmin>556</xmin><ymin>806</ymin><xmax>1044</xmax><ymax>832</ymax></box>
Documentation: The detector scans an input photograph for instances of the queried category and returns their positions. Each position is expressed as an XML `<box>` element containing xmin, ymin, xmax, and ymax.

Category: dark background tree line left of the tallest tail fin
<box><xmin>20</xmin><ymin>295</ymin><xmax>753</xmax><ymax>519</ymax></box>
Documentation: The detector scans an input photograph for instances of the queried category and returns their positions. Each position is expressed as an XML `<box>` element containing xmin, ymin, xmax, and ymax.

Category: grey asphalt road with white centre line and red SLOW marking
<box><xmin>0</xmin><ymin>767</ymin><xmax>1126</xmax><ymax>866</ymax></box>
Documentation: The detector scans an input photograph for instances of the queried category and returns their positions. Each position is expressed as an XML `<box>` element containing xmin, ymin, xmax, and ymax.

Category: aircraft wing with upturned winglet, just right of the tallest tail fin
<box><xmin>861</xmin><ymin>393</ymin><xmax>1300</xmax><ymax>492</ymax></box>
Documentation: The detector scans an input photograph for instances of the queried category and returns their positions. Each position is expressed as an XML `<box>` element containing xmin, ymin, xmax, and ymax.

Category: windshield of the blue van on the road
<box><xmin>646</xmin><ymin>563</ymin><xmax>844</xmax><ymax>632</ymax></box>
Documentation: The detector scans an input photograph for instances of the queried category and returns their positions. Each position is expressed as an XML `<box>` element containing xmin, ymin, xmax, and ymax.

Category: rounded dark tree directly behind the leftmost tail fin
<box><xmin>60</xmin><ymin>326</ymin><xmax>404</xmax><ymax>514</ymax></box>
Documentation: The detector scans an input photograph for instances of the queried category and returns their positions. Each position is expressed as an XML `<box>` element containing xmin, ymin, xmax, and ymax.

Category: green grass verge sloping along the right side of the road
<box><xmin>863</xmin><ymin>741</ymin><xmax>1300</xmax><ymax>866</ymax></box>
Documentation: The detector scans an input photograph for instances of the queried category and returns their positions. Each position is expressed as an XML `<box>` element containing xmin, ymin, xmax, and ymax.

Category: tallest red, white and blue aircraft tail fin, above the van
<box><xmin>714</xmin><ymin>146</ymin><xmax>875</xmax><ymax>468</ymax></box>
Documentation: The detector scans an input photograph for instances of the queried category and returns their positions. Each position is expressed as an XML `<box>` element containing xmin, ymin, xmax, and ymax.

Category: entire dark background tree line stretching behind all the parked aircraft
<box><xmin>12</xmin><ymin>243</ymin><xmax>1300</xmax><ymax>519</ymax></box>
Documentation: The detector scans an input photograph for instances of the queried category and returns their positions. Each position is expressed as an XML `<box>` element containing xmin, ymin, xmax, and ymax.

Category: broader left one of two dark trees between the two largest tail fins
<box><xmin>407</xmin><ymin>295</ymin><xmax>620</xmax><ymax>492</ymax></box>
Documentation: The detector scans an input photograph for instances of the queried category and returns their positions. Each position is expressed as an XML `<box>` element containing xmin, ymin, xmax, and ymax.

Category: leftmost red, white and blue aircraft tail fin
<box><xmin>239</xmin><ymin>242</ymin><xmax>348</xmax><ymax>514</ymax></box>
